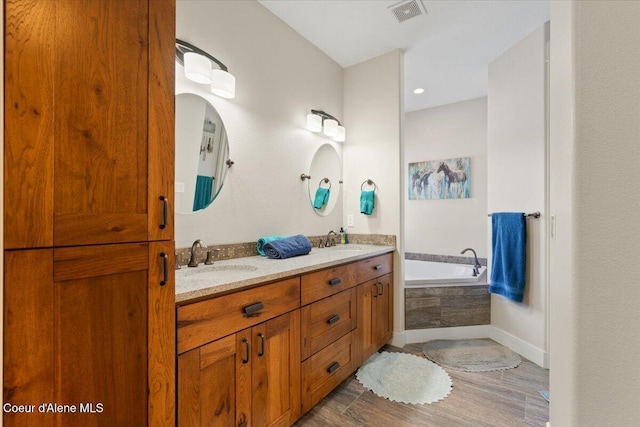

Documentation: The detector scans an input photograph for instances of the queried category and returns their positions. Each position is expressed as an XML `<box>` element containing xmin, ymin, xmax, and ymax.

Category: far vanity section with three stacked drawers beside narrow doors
<box><xmin>301</xmin><ymin>254</ymin><xmax>393</xmax><ymax>413</ymax></box>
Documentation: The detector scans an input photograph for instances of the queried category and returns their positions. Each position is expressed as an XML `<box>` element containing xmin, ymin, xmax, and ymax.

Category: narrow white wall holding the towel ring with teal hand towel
<box><xmin>343</xmin><ymin>50</ymin><xmax>404</xmax><ymax>338</ymax></box>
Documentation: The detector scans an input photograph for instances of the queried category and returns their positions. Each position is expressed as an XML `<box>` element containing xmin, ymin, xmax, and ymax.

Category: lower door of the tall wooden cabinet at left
<box><xmin>4</xmin><ymin>242</ymin><xmax>175</xmax><ymax>427</ymax></box>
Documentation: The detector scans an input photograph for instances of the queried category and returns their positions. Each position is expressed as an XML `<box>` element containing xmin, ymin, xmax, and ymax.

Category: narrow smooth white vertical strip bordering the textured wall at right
<box><xmin>549</xmin><ymin>1</ymin><xmax>578</xmax><ymax>427</ymax></box>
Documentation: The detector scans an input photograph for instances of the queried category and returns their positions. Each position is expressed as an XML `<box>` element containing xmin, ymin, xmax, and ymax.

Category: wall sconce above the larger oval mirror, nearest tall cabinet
<box><xmin>176</xmin><ymin>39</ymin><xmax>236</xmax><ymax>98</ymax></box>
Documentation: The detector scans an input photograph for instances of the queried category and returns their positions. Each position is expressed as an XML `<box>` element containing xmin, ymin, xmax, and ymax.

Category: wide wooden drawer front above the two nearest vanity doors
<box><xmin>177</xmin><ymin>277</ymin><xmax>300</xmax><ymax>354</ymax></box>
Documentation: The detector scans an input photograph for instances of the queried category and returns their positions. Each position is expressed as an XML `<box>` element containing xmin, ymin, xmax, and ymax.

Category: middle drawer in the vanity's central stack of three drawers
<box><xmin>301</xmin><ymin>287</ymin><xmax>358</xmax><ymax>360</ymax></box>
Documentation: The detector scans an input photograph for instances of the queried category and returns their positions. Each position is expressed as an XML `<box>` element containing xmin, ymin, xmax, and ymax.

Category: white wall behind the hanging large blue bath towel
<box><xmin>487</xmin><ymin>26</ymin><xmax>548</xmax><ymax>364</ymax></box>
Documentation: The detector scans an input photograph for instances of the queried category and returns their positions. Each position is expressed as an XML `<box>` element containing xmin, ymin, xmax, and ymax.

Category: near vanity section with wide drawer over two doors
<box><xmin>178</xmin><ymin>277</ymin><xmax>300</xmax><ymax>427</ymax></box>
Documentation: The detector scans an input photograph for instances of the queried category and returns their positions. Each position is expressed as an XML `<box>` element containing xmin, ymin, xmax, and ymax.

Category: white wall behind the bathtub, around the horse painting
<box><xmin>402</xmin><ymin>97</ymin><xmax>487</xmax><ymax>258</ymax></box>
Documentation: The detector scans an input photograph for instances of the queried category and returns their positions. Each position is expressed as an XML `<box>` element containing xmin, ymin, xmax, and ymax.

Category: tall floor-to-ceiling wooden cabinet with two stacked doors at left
<box><xmin>3</xmin><ymin>0</ymin><xmax>175</xmax><ymax>426</ymax></box>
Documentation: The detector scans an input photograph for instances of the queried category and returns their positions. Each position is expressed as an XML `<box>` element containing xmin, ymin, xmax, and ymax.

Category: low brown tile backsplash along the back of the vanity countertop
<box><xmin>176</xmin><ymin>234</ymin><xmax>396</xmax><ymax>266</ymax></box>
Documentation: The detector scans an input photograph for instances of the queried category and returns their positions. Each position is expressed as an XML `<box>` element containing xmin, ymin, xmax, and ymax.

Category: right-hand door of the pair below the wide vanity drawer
<box><xmin>251</xmin><ymin>310</ymin><xmax>300</xmax><ymax>427</ymax></box>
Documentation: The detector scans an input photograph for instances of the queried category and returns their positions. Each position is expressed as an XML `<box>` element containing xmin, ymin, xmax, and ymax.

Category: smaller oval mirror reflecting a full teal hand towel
<box><xmin>307</xmin><ymin>144</ymin><xmax>342</xmax><ymax>216</ymax></box>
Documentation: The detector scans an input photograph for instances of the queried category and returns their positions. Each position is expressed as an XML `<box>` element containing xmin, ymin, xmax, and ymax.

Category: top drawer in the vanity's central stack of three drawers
<box><xmin>301</xmin><ymin>263</ymin><xmax>358</xmax><ymax>305</ymax></box>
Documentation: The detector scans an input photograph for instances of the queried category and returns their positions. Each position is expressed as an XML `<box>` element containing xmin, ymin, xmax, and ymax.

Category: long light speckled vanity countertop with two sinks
<box><xmin>176</xmin><ymin>244</ymin><xmax>395</xmax><ymax>305</ymax></box>
